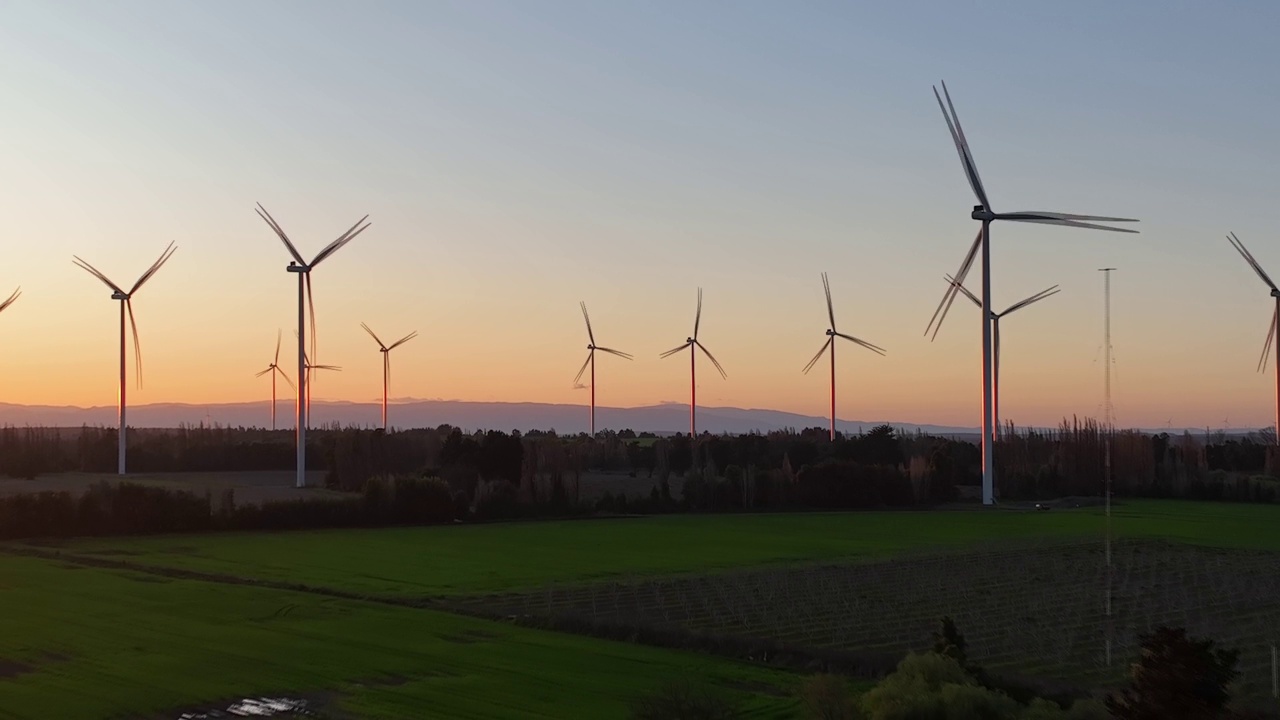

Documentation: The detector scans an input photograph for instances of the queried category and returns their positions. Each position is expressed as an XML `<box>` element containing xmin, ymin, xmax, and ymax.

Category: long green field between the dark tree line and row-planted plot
<box><xmin>37</xmin><ymin>501</ymin><xmax>1280</xmax><ymax>597</ymax></box>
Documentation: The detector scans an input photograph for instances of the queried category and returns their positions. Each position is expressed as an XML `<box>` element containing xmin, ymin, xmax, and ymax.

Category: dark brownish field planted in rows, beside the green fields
<box><xmin>445</xmin><ymin>541</ymin><xmax>1280</xmax><ymax>694</ymax></box>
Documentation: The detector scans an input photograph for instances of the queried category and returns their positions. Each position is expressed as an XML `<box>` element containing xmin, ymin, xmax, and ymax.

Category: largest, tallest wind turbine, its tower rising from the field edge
<box><xmin>924</xmin><ymin>82</ymin><xmax>1138</xmax><ymax>505</ymax></box>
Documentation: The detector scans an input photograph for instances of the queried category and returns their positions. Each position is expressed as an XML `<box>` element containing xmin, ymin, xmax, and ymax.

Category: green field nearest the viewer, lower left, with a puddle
<box><xmin>0</xmin><ymin>555</ymin><xmax>797</xmax><ymax>720</ymax></box>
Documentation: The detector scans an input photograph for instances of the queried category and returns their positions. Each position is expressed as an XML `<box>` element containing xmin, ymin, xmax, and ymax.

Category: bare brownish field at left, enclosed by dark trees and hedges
<box><xmin>0</xmin><ymin>470</ymin><xmax>346</xmax><ymax>503</ymax></box>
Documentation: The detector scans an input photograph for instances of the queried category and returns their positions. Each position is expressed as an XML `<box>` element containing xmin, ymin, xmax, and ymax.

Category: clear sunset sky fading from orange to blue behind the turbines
<box><xmin>0</xmin><ymin>0</ymin><xmax>1280</xmax><ymax>428</ymax></box>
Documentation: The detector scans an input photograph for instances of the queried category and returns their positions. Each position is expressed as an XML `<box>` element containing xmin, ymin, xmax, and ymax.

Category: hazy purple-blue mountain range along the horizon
<box><xmin>0</xmin><ymin>400</ymin><xmax>1249</xmax><ymax>441</ymax></box>
